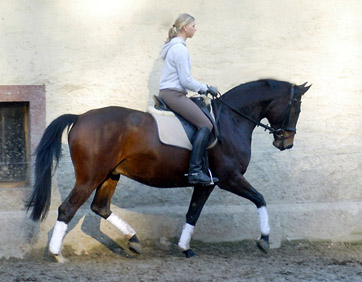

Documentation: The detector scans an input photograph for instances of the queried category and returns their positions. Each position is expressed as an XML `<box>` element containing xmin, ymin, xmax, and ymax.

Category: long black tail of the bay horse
<box><xmin>25</xmin><ymin>114</ymin><xmax>79</xmax><ymax>221</ymax></box>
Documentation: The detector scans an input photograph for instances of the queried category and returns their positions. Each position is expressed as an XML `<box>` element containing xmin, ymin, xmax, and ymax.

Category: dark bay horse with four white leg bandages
<box><xmin>25</xmin><ymin>79</ymin><xmax>311</xmax><ymax>262</ymax></box>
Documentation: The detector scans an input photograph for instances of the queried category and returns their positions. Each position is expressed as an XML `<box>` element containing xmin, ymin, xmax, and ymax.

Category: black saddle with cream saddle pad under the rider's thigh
<box><xmin>148</xmin><ymin>96</ymin><xmax>218</xmax><ymax>150</ymax></box>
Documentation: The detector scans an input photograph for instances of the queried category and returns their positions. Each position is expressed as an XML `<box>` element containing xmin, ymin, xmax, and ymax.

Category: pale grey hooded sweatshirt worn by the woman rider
<box><xmin>160</xmin><ymin>37</ymin><xmax>207</xmax><ymax>93</ymax></box>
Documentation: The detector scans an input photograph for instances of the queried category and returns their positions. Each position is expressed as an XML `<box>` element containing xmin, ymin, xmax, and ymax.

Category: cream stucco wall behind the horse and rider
<box><xmin>0</xmin><ymin>0</ymin><xmax>362</xmax><ymax>257</ymax></box>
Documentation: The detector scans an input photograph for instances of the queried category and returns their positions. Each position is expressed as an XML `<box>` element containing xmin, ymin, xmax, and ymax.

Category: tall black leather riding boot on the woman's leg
<box><xmin>188</xmin><ymin>126</ymin><xmax>219</xmax><ymax>185</ymax></box>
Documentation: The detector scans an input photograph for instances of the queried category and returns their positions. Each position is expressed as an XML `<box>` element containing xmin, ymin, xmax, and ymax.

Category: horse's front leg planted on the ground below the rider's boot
<box><xmin>178</xmin><ymin>185</ymin><xmax>215</xmax><ymax>258</ymax></box>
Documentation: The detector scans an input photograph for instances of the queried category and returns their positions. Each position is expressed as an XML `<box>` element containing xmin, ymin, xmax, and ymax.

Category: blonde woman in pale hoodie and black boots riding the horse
<box><xmin>159</xmin><ymin>14</ymin><xmax>218</xmax><ymax>185</ymax></box>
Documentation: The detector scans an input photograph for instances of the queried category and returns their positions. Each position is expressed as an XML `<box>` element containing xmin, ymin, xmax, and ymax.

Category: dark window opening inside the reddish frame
<box><xmin>0</xmin><ymin>102</ymin><xmax>29</xmax><ymax>184</ymax></box>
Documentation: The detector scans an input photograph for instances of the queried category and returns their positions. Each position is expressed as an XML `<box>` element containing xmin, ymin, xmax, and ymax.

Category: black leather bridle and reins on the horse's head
<box><xmin>213</xmin><ymin>84</ymin><xmax>297</xmax><ymax>141</ymax></box>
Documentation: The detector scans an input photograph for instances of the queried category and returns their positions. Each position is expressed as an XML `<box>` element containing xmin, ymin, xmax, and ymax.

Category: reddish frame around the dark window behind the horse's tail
<box><xmin>0</xmin><ymin>85</ymin><xmax>46</xmax><ymax>189</ymax></box>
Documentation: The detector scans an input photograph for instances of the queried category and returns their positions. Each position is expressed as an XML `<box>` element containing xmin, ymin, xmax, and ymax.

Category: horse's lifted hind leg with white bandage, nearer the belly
<box><xmin>91</xmin><ymin>174</ymin><xmax>142</xmax><ymax>254</ymax></box>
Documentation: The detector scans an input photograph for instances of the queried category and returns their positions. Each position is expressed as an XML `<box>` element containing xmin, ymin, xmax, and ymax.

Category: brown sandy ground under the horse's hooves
<box><xmin>0</xmin><ymin>241</ymin><xmax>362</xmax><ymax>281</ymax></box>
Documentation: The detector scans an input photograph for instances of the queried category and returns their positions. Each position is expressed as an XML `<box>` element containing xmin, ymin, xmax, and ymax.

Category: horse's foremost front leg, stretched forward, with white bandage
<box><xmin>218</xmin><ymin>173</ymin><xmax>270</xmax><ymax>253</ymax></box>
